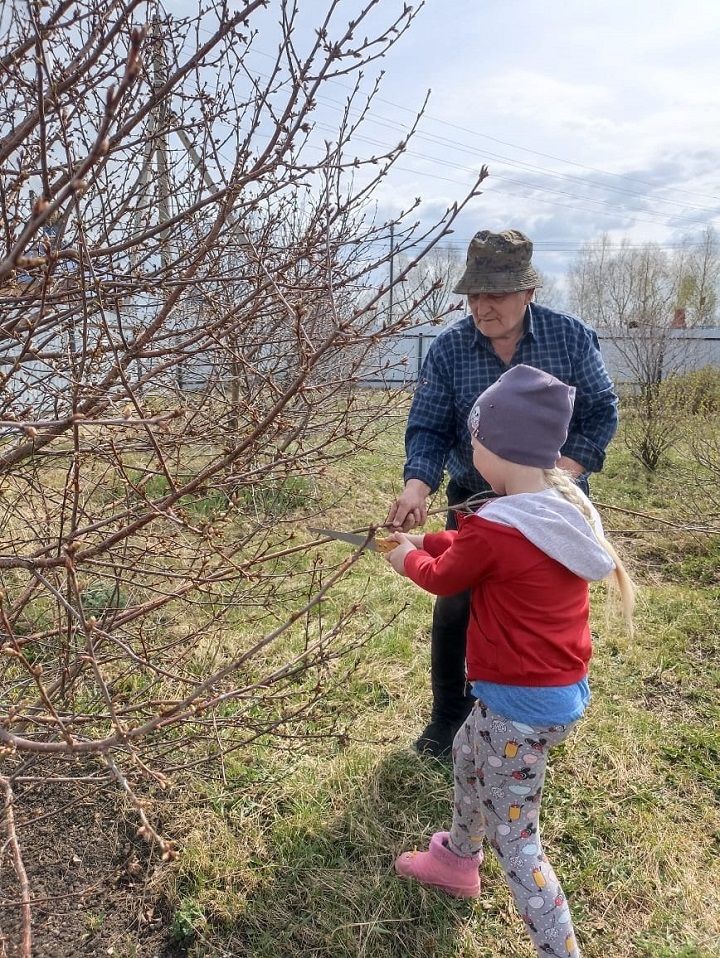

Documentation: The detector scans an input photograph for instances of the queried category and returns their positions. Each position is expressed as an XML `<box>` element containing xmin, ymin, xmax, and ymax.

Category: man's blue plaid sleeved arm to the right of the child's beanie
<box><xmin>558</xmin><ymin>327</ymin><xmax>618</xmax><ymax>475</ymax></box>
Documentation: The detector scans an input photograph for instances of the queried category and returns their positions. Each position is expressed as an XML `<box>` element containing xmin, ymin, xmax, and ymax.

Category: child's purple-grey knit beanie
<box><xmin>468</xmin><ymin>366</ymin><xmax>575</xmax><ymax>469</ymax></box>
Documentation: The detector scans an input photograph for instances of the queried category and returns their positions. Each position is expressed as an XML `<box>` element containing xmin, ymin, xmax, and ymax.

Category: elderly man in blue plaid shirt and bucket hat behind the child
<box><xmin>387</xmin><ymin>230</ymin><xmax>617</xmax><ymax>757</ymax></box>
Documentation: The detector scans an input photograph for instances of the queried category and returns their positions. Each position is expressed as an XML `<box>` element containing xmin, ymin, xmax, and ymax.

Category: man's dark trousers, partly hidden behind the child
<box><xmin>430</xmin><ymin>476</ymin><xmax>588</xmax><ymax>725</ymax></box>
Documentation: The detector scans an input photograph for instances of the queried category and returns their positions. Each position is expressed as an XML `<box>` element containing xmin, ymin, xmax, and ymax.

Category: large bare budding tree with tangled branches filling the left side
<box><xmin>0</xmin><ymin>0</ymin><xmax>485</xmax><ymax>954</ymax></box>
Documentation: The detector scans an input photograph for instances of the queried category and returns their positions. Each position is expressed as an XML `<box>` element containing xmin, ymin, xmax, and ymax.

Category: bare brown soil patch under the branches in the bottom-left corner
<box><xmin>0</xmin><ymin>770</ymin><xmax>184</xmax><ymax>958</ymax></box>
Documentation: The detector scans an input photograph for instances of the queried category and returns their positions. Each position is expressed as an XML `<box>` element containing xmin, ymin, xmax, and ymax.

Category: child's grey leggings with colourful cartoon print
<box><xmin>449</xmin><ymin>701</ymin><xmax>580</xmax><ymax>958</ymax></box>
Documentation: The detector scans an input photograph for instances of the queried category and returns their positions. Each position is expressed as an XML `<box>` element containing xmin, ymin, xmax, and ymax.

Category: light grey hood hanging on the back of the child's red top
<box><xmin>477</xmin><ymin>489</ymin><xmax>615</xmax><ymax>582</ymax></box>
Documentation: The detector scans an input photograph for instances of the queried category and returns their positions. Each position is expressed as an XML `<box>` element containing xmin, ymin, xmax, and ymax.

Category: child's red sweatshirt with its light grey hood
<box><xmin>405</xmin><ymin>490</ymin><xmax>614</xmax><ymax>686</ymax></box>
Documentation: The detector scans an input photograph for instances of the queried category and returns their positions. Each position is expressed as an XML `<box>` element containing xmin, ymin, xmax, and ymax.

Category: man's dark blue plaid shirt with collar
<box><xmin>404</xmin><ymin>303</ymin><xmax>618</xmax><ymax>492</ymax></box>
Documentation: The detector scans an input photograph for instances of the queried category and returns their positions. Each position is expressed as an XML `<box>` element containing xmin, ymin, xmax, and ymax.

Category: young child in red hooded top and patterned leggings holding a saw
<box><xmin>386</xmin><ymin>366</ymin><xmax>634</xmax><ymax>958</ymax></box>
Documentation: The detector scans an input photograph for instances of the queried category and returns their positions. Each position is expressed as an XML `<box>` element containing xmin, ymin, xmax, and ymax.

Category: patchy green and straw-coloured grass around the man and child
<box><xmin>156</xmin><ymin>404</ymin><xmax>720</xmax><ymax>958</ymax></box>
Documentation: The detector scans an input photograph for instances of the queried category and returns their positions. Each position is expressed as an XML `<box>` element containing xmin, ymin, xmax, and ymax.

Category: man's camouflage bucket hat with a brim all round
<box><xmin>453</xmin><ymin>230</ymin><xmax>542</xmax><ymax>295</ymax></box>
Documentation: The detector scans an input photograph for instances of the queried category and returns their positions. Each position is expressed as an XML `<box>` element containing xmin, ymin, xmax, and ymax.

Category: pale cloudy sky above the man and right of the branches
<box><xmin>166</xmin><ymin>0</ymin><xmax>720</xmax><ymax>284</ymax></box>
